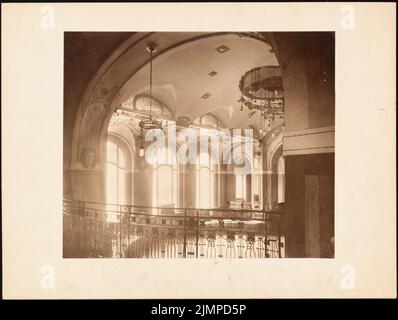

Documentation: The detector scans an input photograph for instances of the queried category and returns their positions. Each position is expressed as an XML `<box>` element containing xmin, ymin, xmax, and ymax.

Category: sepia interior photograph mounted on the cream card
<box><xmin>62</xmin><ymin>32</ymin><xmax>335</xmax><ymax>259</ymax></box>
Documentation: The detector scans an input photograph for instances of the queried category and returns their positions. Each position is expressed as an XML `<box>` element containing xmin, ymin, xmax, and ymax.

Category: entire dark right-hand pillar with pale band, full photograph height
<box><xmin>270</xmin><ymin>32</ymin><xmax>335</xmax><ymax>258</ymax></box>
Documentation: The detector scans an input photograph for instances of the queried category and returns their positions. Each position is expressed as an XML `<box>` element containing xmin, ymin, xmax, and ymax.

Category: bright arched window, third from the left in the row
<box><xmin>196</xmin><ymin>152</ymin><xmax>214</xmax><ymax>208</ymax></box>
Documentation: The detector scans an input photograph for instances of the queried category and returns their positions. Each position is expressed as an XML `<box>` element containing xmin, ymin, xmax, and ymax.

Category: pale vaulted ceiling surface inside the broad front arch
<box><xmin>113</xmin><ymin>33</ymin><xmax>278</xmax><ymax>128</ymax></box>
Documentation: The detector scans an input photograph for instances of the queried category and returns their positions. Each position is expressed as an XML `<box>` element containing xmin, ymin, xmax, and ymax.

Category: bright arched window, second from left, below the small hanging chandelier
<box><xmin>152</xmin><ymin>148</ymin><xmax>178</xmax><ymax>207</ymax></box>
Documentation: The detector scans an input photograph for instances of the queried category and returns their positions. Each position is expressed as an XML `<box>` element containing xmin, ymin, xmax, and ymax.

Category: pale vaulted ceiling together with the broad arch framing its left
<box><xmin>72</xmin><ymin>32</ymin><xmax>278</xmax><ymax>166</ymax></box>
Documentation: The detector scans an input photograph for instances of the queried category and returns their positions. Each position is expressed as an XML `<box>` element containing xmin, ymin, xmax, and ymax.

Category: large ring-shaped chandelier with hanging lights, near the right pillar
<box><xmin>239</xmin><ymin>66</ymin><xmax>285</xmax><ymax>132</ymax></box>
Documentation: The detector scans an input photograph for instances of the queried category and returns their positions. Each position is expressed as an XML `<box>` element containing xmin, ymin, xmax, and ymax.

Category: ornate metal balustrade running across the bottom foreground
<box><xmin>63</xmin><ymin>200</ymin><xmax>284</xmax><ymax>259</ymax></box>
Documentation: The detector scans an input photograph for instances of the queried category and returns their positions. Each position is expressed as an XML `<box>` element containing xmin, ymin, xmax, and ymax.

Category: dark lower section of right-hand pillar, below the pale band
<box><xmin>284</xmin><ymin>153</ymin><xmax>334</xmax><ymax>258</ymax></box>
